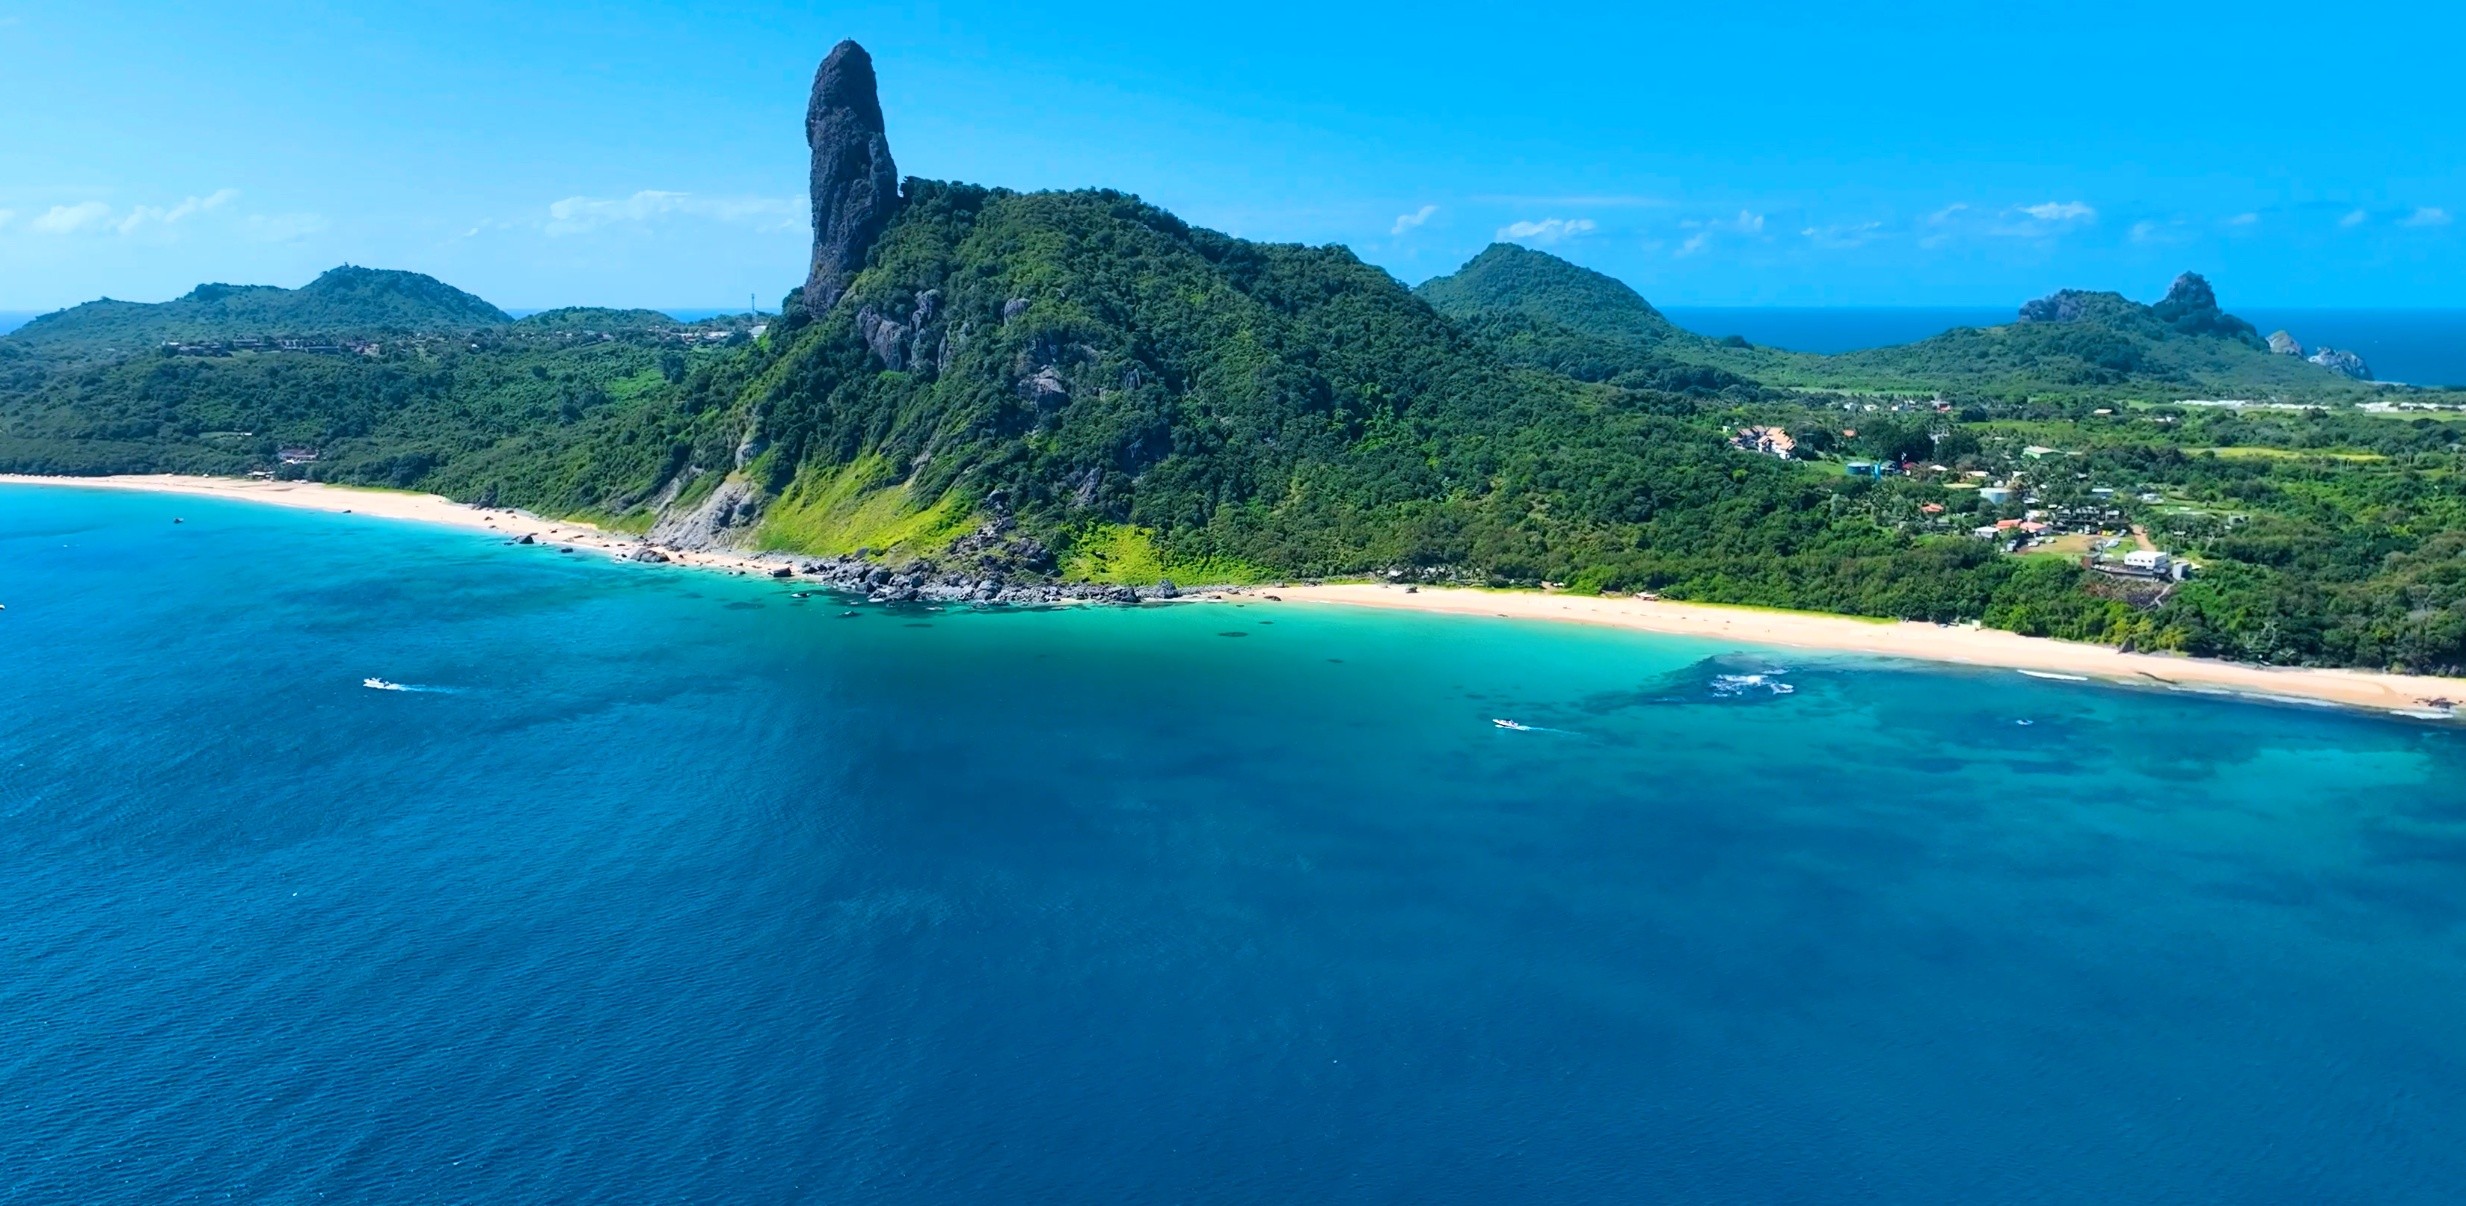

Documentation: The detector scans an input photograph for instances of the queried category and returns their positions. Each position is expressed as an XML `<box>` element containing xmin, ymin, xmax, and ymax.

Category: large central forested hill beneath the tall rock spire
<box><xmin>581</xmin><ymin>180</ymin><xmax>1891</xmax><ymax>580</ymax></box>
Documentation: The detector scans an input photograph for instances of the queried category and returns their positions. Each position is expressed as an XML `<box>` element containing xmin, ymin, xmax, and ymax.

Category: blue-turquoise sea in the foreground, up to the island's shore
<box><xmin>14</xmin><ymin>486</ymin><xmax>2466</xmax><ymax>1204</ymax></box>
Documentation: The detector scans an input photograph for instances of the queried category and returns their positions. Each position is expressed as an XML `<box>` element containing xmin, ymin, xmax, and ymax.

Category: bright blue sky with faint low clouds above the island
<box><xmin>0</xmin><ymin>0</ymin><xmax>2466</xmax><ymax>311</ymax></box>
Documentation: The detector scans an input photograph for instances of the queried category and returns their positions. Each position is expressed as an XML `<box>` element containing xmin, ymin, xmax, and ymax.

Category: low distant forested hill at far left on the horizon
<box><xmin>5</xmin><ymin>264</ymin><xmax>510</xmax><ymax>353</ymax></box>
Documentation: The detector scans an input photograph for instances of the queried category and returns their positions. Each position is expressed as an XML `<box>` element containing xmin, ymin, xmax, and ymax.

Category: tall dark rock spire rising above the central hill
<box><xmin>804</xmin><ymin>42</ymin><xmax>900</xmax><ymax>313</ymax></box>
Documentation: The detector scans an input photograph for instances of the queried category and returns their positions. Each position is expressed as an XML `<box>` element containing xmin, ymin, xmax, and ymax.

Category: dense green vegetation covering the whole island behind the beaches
<box><xmin>14</xmin><ymin>180</ymin><xmax>2466</xmax><ymax>671</ymax></box>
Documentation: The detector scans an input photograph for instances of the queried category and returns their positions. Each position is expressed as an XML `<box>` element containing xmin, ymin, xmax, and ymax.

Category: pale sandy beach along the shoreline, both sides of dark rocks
<box><xmin>0</xmin><ymin>474</ymin><xmax>2466</xmax><ymax>720</ymax></box>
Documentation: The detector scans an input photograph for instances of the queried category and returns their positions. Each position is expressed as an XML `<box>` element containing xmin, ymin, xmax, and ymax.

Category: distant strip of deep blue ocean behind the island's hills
<box><xmin>0</xmin><ymin>306</ymin><xmax>2466</xmax><ymax>385</ymax></box>
